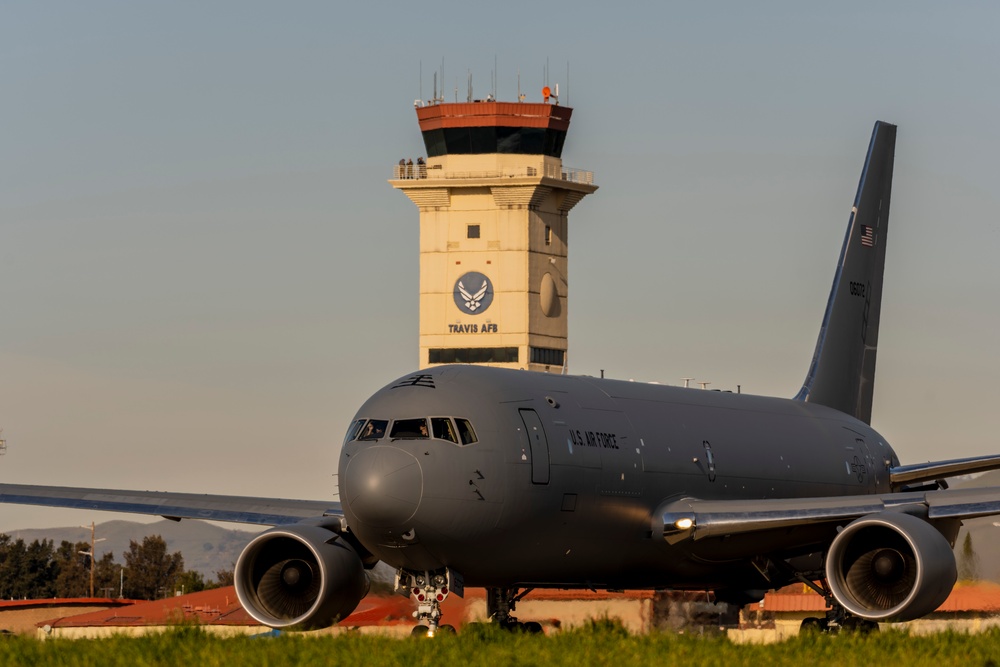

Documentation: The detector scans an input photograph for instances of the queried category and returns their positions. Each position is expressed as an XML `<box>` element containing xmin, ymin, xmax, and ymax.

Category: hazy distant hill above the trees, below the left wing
<box><xmin>7</xmin><ymin>519</ymin><xmax>263</xmax><ymax>580</ymax></box>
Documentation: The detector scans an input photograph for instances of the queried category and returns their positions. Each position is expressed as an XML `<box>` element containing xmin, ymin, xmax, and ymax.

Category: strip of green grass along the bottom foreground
<box><xmin>0</xmin><ymin>624</ymin><xmax>1000</xmax><ymax>667</ymax></box>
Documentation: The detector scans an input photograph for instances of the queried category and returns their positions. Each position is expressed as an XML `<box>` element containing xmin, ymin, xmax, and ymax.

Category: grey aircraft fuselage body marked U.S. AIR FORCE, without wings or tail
<box><xmin>340</xmin><ymin>366</ymin><xmax>898</xmax><ymax>588</ymax></box>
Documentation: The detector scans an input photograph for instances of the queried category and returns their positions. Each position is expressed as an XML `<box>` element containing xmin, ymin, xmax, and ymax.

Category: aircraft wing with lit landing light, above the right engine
<box><xmin>661</xmin><ymin>486</ymin><xmax>1000</xmax><ymax>543</ymax></box>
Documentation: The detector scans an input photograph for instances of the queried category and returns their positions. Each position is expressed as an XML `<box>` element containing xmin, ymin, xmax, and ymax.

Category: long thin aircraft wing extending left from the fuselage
<box><xmin>0</xmin><ymin>484</ymin><xmax>344</xmax><ymax>526</ymax></box>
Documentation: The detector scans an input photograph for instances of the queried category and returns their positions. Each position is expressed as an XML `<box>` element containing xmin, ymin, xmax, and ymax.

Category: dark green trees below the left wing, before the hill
<box><xmin>0</xmin><ymin>533</ymin><xmax>233</xmax><ymax>600</ymax></box>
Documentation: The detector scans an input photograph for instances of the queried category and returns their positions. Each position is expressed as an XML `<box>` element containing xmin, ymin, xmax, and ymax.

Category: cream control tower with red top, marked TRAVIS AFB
<box><xmin>389</xmin><ymin>89</ymin><xmax>597</xmax><ymax>373</ymax></box>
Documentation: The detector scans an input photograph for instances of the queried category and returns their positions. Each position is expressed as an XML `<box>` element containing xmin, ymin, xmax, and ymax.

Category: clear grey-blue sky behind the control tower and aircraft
<box><xmin>0</xmin><ymin>0</ymin><xmax>1000</xmax><ymax>530</ymax></box>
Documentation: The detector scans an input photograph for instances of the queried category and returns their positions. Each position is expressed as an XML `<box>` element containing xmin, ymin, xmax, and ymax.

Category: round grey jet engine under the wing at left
<box><xmin>234</xmin><ymin>525</ymin><xmax>368</xmax><ymax>630</ymax></box>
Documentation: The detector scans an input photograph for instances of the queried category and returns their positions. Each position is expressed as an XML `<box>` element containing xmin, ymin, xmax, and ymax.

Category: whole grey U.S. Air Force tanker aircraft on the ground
<box><xmin>0</xmin><ymin>122</ymin><xmax>1000</xmax><ymax>634</ymax></box>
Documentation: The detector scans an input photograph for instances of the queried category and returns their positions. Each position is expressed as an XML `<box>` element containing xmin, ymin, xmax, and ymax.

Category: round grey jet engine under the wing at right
<box><xmin>826</xmin><ymin>512</ymin><xmax>958</xmax><ymax>621</ymax></box>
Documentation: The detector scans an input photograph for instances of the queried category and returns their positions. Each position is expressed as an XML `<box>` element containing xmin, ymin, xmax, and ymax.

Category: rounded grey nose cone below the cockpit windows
<box><xmin>341</xmin><ymin>445</ymin><xmax>424</xmax><ymax>527</ymax></box>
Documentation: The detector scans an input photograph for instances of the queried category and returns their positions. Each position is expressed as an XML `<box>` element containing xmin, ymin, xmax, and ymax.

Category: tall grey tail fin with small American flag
<box><xmin>795</xmin><ymin>121</ymin><xmax>896</xmax><ymax>423</ymax></box>
